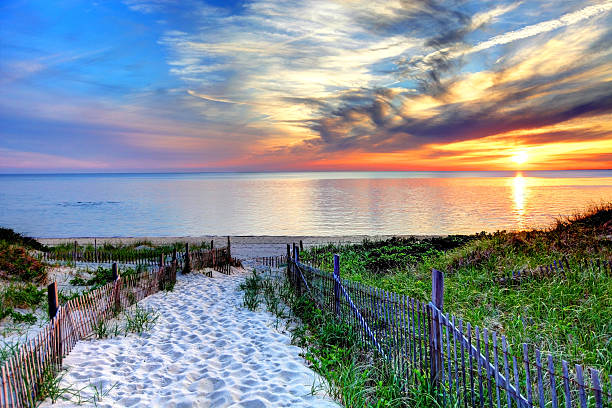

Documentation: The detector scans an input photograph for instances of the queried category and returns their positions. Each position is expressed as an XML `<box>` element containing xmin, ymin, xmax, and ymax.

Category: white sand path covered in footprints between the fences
<box><xmin>42</xmin><ymin>272</ymin><xmax>339</xmax><ymax>408</ymax></box>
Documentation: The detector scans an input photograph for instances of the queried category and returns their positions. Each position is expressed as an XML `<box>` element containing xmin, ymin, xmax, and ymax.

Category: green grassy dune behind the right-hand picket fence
<box><xmin>302</xmin><ymin>204</ymin><xmax>612</xmax><ymax>375</ymax></box>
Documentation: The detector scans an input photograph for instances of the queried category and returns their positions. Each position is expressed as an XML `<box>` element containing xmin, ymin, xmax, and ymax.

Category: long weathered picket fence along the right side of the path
<box><xmin>286</xmin><ymin>244</ymin><xmax>612</xmax><ymax>408</ymax></box>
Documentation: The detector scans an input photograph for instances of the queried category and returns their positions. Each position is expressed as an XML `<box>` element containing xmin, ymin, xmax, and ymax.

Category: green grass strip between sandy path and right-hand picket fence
<box><xmin>240</xmin><ymin>271</ymin><xmax>450</xmax><ymax>408</ymax></box>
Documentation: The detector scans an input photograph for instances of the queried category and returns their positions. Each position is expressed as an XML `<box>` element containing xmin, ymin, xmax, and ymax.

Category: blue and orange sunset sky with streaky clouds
<box><xmin>0</xmin><ymin>0</ymin><xmax>612</xmax><ymax>173</ymax></box>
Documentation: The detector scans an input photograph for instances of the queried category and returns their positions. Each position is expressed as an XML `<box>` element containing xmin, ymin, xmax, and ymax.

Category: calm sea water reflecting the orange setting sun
<box><xmin>0</xmin><ymin>170</ymin><xmax>612</xmax><ymax>237</ymax></box>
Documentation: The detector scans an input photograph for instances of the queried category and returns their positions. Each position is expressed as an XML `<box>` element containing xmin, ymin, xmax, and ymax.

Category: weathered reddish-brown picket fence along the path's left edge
<box><xmin>0</xmin><ymin>262</ymin><xmax>177</xmax><ymax>408</ymax></box>
